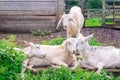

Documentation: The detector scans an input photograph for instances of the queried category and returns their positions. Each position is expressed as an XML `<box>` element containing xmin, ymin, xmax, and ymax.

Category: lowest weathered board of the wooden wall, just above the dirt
<box><xmin>0</xmin><ymin>23</ymin><xmax>55</xmax><ymax>32</ymax></box>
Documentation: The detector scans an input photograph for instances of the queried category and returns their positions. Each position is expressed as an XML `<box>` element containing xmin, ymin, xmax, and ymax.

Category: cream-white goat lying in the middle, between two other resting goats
<box><xmin>23</xmin><ymin>38</ymin><xmax>77</xmax><ymax>70</ymax></box>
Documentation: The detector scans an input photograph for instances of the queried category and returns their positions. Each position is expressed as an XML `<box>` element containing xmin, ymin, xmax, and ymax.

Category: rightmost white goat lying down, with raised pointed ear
<box><xmin>73</xmin><ymin>34</ymin><xmax>120</xmax><ymax>73</ymax></box>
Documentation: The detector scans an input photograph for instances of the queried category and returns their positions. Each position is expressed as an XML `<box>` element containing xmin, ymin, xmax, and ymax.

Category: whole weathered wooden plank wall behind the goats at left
<box><xmin>0</xmin><ymin>0</ymin><xmax>65</xmax><ymax>32</ymax></box>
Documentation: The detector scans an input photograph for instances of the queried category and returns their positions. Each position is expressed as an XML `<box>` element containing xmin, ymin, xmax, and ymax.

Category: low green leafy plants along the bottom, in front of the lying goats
<box><xmin>25</xmin><ymin>67</ymin><xmax>120</xmax><ymax>80</ymax></box>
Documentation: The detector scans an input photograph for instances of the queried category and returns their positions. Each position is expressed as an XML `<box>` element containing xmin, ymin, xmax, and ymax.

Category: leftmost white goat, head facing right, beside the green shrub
<box><xmin>20</xmin><ymin>42</ymin><xmax>46</xmax><ymax>79</ymax></box>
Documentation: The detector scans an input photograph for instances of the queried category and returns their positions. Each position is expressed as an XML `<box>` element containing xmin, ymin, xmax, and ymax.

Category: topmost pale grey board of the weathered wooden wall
<box><xmin>0</xmin><ymin>2</ymin><xmax>56</xmax><ymax>11</ymax></box>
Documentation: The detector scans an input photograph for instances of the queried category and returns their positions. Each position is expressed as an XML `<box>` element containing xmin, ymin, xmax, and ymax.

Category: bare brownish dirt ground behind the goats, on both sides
<box><xmin>0</xmin><ymin>28</ymin><xmax>120</xmax><ymax>47</ymax></box>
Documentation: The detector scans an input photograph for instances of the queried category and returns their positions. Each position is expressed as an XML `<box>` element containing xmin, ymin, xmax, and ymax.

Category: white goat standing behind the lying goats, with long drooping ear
<box><xmin>56</xmin><ymin>6</ymin><xmax>84</xmax><ymax>38</ymax></box>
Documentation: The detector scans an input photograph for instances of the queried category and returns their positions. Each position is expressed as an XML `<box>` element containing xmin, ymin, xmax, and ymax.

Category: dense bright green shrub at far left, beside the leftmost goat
<box><xmin>0</xmin><ymin>35</ymin><xmax>24</xmax><ymax>80</ymax></box>
